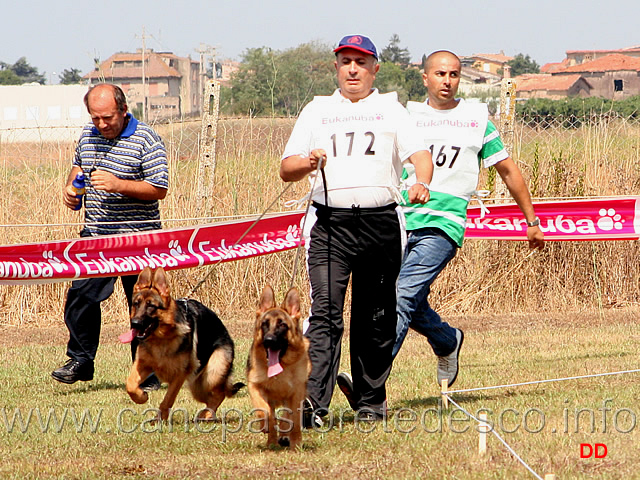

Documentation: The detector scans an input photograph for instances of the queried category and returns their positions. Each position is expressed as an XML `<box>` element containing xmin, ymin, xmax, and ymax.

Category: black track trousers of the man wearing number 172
<box><xmin>306</xmin><ymin>204</ymin><xmax>402</xmax><ymax>413</ymax></box>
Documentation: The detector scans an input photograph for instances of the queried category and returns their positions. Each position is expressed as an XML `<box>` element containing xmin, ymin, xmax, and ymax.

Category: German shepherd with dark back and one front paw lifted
<box><xmin>120</xmin><ymin>267</ymin><xmax>244</xmax><ymax>420</ymax></box>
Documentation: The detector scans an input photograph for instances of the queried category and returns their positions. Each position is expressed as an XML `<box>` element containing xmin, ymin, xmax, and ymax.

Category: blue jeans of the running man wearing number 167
<box><xmin>393</xmin><ymin>228</ymin><xmax>458</xmax><ymax>358</ymax></box>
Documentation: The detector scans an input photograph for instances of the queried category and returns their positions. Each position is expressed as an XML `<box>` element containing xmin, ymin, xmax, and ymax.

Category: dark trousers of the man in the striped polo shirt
<box><xmin>64</xmin><ymin>275</ymin><xmax>138</xmax><ymax>363</ymax></box>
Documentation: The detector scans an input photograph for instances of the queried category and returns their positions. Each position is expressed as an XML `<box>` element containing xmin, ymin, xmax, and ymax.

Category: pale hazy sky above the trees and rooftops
<box><xmin>0</xmin><ymin>0</ymin><xmax>640</xmax><ymax>83</ymax></box>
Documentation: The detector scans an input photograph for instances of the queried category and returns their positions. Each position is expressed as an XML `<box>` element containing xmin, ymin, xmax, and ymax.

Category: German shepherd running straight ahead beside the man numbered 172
<box><xmin>247</xmin><ymin>285</ymin><xmax>311</xmax><ymax>449</ymax></box>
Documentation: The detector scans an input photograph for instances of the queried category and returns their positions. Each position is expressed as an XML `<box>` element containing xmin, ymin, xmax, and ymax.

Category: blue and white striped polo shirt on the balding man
<box><xmin>73</xmin><ymin>113</ymin><xmax>169</xmax><ymax>236</ymax></box>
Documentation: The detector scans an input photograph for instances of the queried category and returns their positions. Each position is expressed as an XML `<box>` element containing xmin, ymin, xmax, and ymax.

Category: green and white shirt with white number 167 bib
<box><xmin>402</xmin><ymin>99</ymin><xmax>509</xmax><ymax>247</ymax></box>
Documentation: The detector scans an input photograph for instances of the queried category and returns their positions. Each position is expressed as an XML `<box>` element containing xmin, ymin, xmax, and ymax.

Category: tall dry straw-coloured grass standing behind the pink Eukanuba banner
<box><xmin>0</xmin><ymin>115</ymin><xmax>640</xmax><ymax>325</ymax></box>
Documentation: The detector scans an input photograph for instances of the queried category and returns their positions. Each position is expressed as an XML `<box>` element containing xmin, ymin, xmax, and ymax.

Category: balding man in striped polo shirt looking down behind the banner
<box><xmin>51</xmin><ymin>84</ymin><xmax>169</xmax><ymax>388</ymax></box>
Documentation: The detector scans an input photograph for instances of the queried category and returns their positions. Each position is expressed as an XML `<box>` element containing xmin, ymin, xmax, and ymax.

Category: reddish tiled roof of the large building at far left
<box><xmin>83</xmin><ymin>52</ymin><xmax>182</xmax><ymax>79</ymax></box>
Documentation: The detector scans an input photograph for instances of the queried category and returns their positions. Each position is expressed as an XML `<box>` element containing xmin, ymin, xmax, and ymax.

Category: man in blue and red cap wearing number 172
<box><xmin>280</xmin><ymin>35</ymin><xmax>433</xmax><ymax>427</ymax></box>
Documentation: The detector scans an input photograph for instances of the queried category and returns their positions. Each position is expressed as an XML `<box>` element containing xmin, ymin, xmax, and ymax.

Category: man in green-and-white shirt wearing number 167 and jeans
<box><xmin>393</xmin><ymin>50</ymin><xmax>544</xmax><ymax>385</ymax></box>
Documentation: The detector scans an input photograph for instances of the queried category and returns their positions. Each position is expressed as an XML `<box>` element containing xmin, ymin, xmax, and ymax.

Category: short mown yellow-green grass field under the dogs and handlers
<box><xmin>0</xmin><ymin>310</ymin><xmax>640</xmax><ymax>479</ymax></box>
